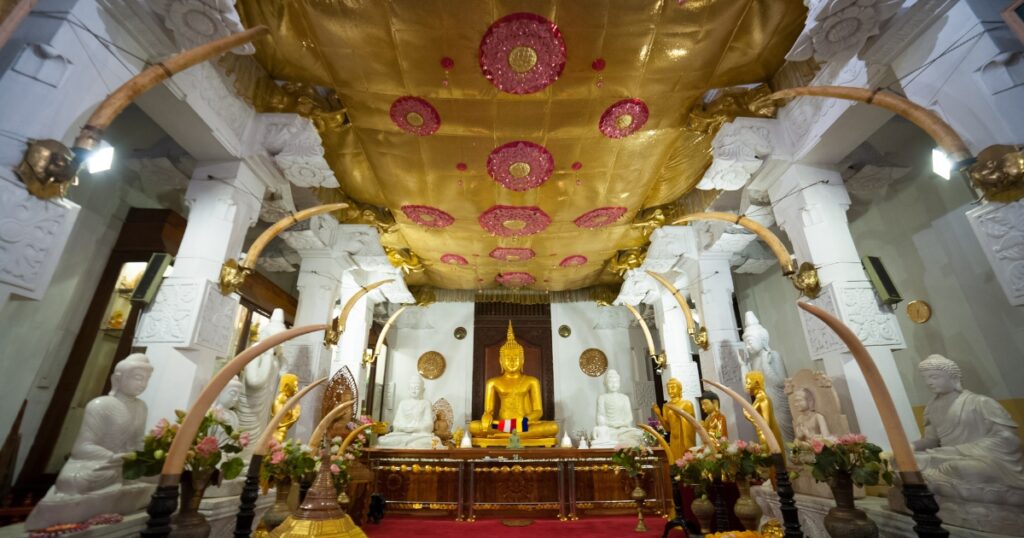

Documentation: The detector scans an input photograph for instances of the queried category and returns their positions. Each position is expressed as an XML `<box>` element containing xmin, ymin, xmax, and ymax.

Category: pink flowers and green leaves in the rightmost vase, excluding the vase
<box><xmin>791</xmin><ymin>433</ymin><xmax>893</xmax><ymax>487</ymax></box>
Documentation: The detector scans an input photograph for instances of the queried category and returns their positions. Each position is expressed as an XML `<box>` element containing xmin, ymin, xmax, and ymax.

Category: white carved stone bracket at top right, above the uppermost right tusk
<box><xmin>785</xmin><ymin>0</ymin><xmax>903</xmax><ymax>61</ymax></box>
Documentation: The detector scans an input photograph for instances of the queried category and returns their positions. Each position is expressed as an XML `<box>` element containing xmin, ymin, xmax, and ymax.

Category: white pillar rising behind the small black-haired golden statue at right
<box><xmin>695</xmin><ymin>251</ymin><xmax>755</xmax><ymax>440</ymax></box>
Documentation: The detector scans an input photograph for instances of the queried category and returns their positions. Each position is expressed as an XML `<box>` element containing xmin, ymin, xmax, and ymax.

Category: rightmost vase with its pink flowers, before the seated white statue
<box><xmin>791</xmin><ymin>433</ymin><xmax>893</xmax><ymax>538</ymax></box>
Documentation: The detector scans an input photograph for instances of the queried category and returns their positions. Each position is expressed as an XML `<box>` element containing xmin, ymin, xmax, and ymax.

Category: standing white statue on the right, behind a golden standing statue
<box><xmin>740</xmin><ymin>312</ymin><xmax>793</xmax><ymax>441</ymax></box>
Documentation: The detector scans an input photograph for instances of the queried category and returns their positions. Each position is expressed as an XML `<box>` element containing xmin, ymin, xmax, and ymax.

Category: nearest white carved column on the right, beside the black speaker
<box><xmin>769</xmin><ymin>164</ymin><xmax>918</xmax><ymax>447</ymax></box>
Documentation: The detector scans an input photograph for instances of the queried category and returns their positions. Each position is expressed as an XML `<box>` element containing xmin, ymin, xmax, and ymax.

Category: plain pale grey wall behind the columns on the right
<box><xmin>735</xmin><ymin>121</ymin><xmax>1024</xmax><ymax>434</ymax></box>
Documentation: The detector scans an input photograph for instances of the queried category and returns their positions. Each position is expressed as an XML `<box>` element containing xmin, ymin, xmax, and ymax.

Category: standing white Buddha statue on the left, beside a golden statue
<box><xmin>238</xmin><ymin>308</ymin><xmax>285</xmax><ymax>439</ymax></box>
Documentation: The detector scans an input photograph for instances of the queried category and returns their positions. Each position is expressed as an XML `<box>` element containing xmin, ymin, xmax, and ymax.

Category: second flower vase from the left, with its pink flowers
<box><xmin>260</xmin><ymin>439</ymin><xmax>316</xmax><ymax>530</ymax></box>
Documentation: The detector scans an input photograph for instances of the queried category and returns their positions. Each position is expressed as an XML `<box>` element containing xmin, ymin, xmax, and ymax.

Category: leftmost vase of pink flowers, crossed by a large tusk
<box><xmin>123</xmin><ymin>410</ymin><xmax>249</xmax><ymax>537</ymax></box>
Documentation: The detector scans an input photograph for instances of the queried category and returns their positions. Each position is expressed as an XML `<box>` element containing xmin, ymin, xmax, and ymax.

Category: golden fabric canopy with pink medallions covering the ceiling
<box><xmin>238</xmin><ymin>0</ymin><xmax>806</xmax><ymax>291</ymax></box>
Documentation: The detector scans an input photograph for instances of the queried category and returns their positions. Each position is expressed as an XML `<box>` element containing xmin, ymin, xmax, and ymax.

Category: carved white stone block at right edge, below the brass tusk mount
<box><xmin>967</xmin><ymin>200</ymin><xmax>1024</xmax><ymax>306</ymax></box>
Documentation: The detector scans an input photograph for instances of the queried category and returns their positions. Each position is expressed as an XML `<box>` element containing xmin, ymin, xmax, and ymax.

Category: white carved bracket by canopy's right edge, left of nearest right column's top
<box><xmin>697</xmin><ymin>118</ymin><xmax>772</xmax><ymax>191</ymax></box>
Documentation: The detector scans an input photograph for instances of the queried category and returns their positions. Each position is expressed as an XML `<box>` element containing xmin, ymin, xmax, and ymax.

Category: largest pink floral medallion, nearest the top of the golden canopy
<box><xmin>480</xmin><ymin>13</ymin><xmax>565</xmax><ymax>94</ymax></box>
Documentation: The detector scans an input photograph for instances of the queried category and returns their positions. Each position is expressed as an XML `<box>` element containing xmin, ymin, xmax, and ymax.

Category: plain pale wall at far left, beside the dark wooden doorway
<box><xmin>0</xmin><ymin>169</ymin><xmax>159</xmax><ymax>472</ymax></box>
